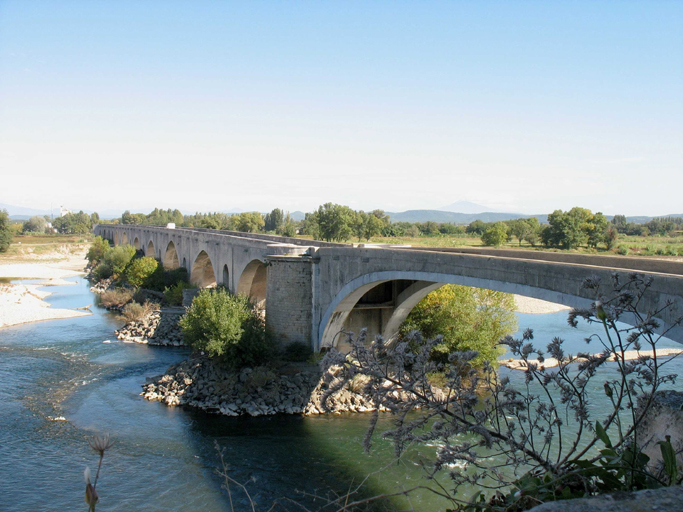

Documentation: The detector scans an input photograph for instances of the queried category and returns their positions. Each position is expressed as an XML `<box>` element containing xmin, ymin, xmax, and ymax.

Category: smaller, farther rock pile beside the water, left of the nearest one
<box><xmin>116</xmin><ymin>309</ymin><xmax>183</xmax><ymax>347</ymax></box>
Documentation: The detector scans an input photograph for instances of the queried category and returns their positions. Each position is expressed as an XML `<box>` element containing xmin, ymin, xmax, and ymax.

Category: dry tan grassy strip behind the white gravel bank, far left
<box><xmin>0</xmin><ymin>235</ymin><xmax>92</xmax><ymax>262</ymax></box>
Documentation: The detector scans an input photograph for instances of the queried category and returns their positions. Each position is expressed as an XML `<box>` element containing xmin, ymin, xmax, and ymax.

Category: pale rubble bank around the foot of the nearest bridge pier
<box><xmin>141</xmin><ymin>357</ymin><xmax>388</xmax><ymax>416</ymax></box>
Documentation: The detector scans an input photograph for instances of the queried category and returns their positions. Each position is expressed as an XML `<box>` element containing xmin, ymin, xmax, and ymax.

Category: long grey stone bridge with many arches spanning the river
<box><xmin>95</xmin><ymin>224</ymin><xmax>683</xmax><ymax>350</ymax></box>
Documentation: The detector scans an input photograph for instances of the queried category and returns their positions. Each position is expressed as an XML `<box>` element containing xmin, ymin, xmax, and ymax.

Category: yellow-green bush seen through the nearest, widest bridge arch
<box><xmin>400</xmin><ymin>284</ymin><xmax>517</xmax><ymax>367</ymax></box>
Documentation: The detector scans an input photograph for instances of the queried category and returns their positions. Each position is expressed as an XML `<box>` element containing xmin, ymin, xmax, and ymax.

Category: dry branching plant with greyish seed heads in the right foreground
<box><xmin>323</xmin><ymin>274</ymin><xmax>683</xmax><ymax>511</ymax></box>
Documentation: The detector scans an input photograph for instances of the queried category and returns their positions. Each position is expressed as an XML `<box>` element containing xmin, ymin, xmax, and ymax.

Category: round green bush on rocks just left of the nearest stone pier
<box><xmin>179</xmin><ymin>288</ymin><xmax>273</xmax><ymax>367</ymax></box>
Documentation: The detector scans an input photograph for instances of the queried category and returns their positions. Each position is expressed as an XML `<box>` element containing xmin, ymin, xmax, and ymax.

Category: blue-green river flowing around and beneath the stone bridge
<box><xmin>0</xmin><ymin>278</ymin><xmax>683</xmax><ymax>511</ymax></box>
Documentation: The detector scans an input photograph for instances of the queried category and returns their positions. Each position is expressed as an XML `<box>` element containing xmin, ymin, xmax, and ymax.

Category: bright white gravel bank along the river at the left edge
<box><xmin>0</xmin><ymin>250</ymin><xmax>90</xmax><ymax>328</ymax></box>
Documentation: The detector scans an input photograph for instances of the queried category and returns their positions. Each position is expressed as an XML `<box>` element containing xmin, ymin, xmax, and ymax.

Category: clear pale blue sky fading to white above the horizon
<box><xmin>0</xmin><ymin>0</ymin><xmax>683</xmax><ymax>215</ymax></box>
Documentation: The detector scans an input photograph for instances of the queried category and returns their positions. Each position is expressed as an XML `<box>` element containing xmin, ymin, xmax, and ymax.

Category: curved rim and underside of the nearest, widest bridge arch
<box><xmin>316</xmin><ymin>271</ymin><xmax>591</xmax><ymax>350</ymax></box>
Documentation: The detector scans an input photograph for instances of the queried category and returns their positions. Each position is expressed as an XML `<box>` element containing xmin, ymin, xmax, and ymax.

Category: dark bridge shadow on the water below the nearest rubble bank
<box><xmin>188</xmin><ymin>402</ymin><xmax>446</xmax><ymax>511</ymax></box>
